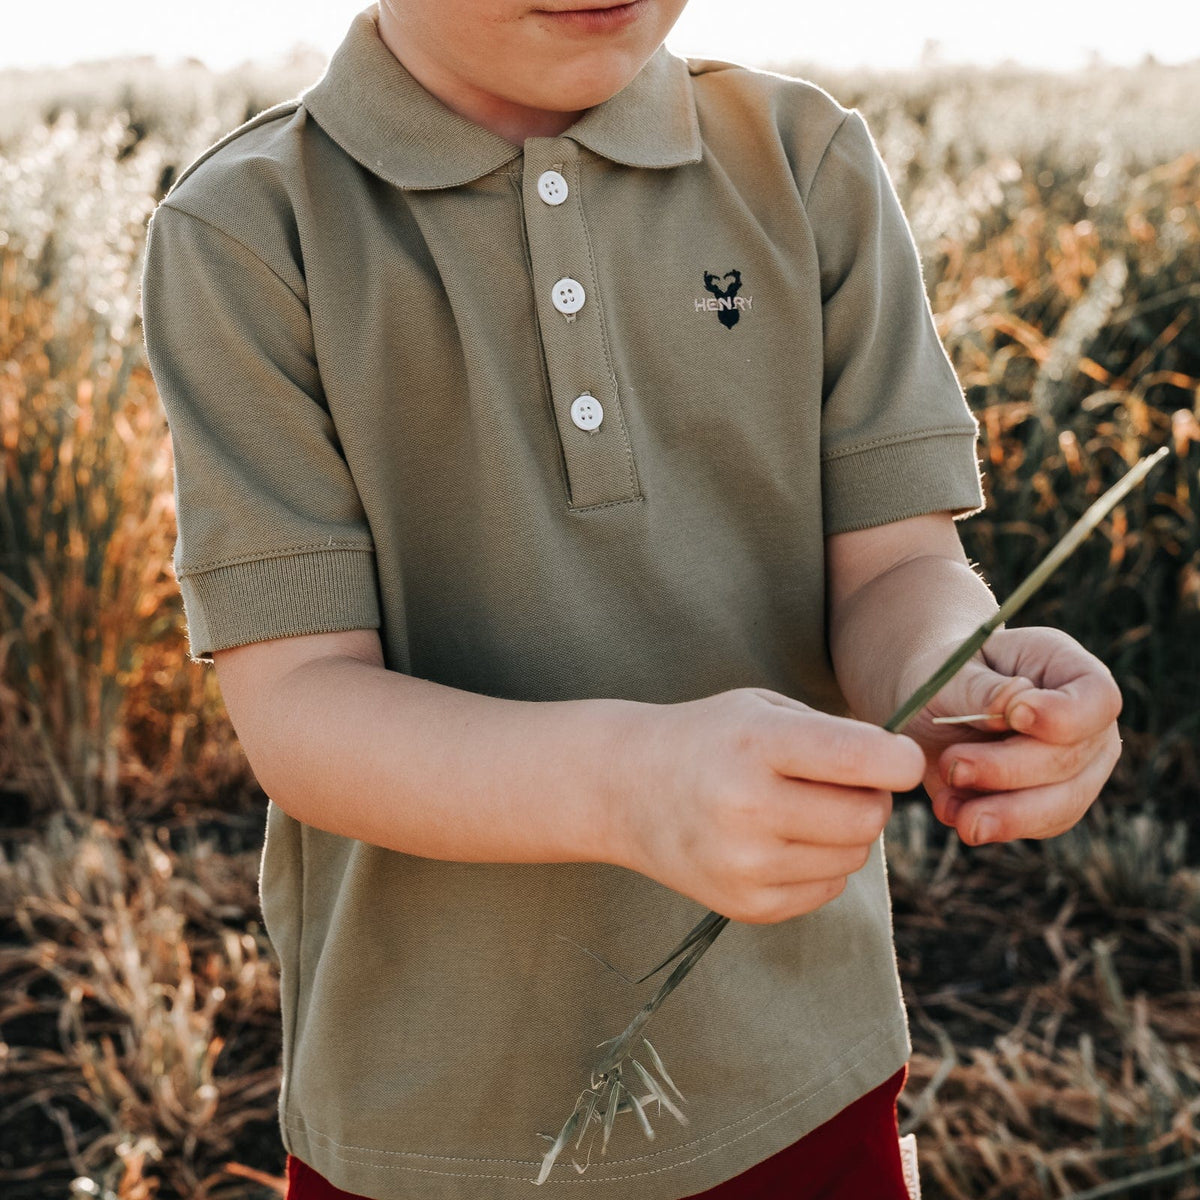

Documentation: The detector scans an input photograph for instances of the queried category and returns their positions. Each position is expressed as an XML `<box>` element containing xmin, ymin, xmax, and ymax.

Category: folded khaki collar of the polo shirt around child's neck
<box><xmin>300</xmin><ymin>0</ymin><xmax>701</xmax><ymax>188</ymax></box>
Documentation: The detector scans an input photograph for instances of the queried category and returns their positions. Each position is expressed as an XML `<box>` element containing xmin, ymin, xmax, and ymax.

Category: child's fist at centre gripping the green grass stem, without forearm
<box><xmin>617</xmin><ymin>688</ymin><xmax>925</xmax><ymax>925</ymax></box>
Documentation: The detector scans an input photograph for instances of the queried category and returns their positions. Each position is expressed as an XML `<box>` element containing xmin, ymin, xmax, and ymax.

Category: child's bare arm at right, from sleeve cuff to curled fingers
<box><xmin>826</xmin><ymin>512</ymin><xmax>1121</xmax><ymax>845</ymax></box>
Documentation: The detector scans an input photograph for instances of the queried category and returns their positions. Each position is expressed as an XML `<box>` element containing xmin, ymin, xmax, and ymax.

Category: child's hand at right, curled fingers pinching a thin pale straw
<box><xmin>907</xmin><ymin>628</ymin><xmax>1121</xmax><ymax>845</ymax></box>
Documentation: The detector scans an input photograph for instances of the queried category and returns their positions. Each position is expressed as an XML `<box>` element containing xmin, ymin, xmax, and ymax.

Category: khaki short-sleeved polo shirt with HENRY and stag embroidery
<box><xmin>143</xmin><ymin>7</ymin><xmax>982</xmax><ymax>1200</ymax></box>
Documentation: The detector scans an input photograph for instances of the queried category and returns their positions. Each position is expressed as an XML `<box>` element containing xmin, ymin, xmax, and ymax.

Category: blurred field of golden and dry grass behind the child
<box><xmin>0</xmin><ymin>55</ymin><xmax>1200</xmax><ymax>1200</ymax></box>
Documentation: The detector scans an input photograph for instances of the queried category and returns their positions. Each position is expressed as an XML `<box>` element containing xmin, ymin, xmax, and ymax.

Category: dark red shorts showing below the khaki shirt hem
<box><xmin>284</xmin><ymin>1063</ymin><xmax>910</xmax><ymax>1200</ymax></box>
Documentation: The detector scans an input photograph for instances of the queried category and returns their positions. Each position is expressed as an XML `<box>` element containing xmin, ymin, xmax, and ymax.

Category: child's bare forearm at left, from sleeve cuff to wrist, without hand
<box><xmin>212</xmin><ymin>629</ymin><xmax>635</xmax><ymax>863</ymax></box>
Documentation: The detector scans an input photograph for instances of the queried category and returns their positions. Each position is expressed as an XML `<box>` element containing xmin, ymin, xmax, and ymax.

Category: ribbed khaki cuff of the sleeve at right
<box><xmin>821</xmin><ymin>430</ymin><xmax>984</xmax><ymax>534</ymax></box>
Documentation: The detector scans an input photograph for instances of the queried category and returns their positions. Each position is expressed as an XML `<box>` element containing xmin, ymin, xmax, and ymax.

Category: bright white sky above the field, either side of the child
<box><xmin>7</xmin><ymin>0</ymin><xmax>1200</xmax><ymax>70</ymax></box>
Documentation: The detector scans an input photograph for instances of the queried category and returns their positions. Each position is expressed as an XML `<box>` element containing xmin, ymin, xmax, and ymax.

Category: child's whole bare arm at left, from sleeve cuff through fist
<box><xmin>214</xmin><ymin>629</ymin><xmax>924</xmax><ymax>924</ymax></box>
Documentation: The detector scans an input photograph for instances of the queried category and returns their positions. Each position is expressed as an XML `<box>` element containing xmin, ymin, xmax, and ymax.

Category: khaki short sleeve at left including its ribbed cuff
<box><xmin>142</xmin><ymin>204</ymin><xmax>379</xmax><ymax>661</ymax></box>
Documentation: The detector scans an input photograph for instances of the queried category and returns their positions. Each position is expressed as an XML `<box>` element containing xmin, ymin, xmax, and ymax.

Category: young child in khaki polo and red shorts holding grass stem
<box><xmin>143</xmin><ymin>0</ymin><xmax>1120</xmax><ymax>1200</ymax></box>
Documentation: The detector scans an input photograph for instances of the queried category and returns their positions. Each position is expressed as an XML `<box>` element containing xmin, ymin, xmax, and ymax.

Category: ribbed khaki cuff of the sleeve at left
<box><xmin>179</xmin><ymin>550</ymin><xmax>379</xmax><ymax>662</ymax></box>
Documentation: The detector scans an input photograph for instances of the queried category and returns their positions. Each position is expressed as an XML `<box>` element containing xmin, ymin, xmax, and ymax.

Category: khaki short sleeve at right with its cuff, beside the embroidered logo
<box><xmin>806</xmin><ymin>109</ymin><xmax>983</xmax><ymax>534</ymax></box>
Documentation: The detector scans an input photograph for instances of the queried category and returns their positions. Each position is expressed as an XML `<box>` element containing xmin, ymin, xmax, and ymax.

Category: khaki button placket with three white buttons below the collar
<box><xmin>522</xmin><ymin>145</ymin><xmax>641</xmax><ymax>508</ymax></box>
